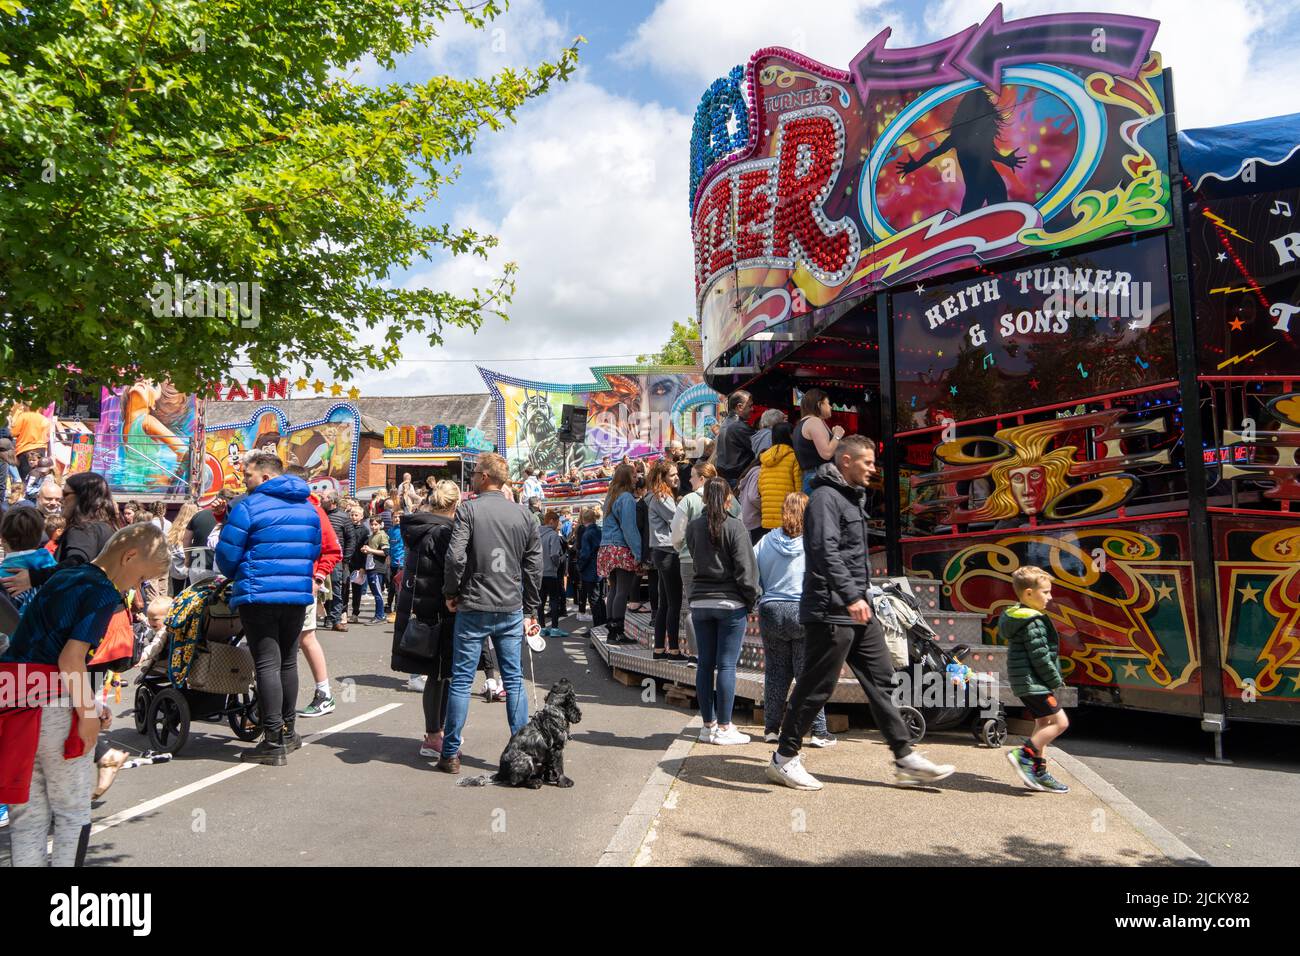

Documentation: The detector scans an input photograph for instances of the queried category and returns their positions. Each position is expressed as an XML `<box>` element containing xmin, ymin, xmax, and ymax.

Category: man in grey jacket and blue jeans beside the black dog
<box><xmin>438</xmin><ymin>453</ymin><xmax>542</xmax><ymax>774</ymax></box>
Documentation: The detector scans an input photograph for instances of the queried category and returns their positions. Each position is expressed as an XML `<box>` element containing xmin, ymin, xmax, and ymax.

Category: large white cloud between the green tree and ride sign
<box><xmin>335</xmin><ymin>78</ymin><xmax>694</xmax><ymax>394</ymax></box>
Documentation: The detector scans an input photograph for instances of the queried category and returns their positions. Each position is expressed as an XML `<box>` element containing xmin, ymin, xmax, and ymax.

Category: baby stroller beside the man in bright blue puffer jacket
<box><xmin>134</xmin><ymin>575</ymin><xmax>261</xmax><ymax>754</ymax></box>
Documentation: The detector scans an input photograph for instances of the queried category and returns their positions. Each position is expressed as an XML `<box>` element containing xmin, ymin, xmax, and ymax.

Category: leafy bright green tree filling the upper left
<box><xmin>0</xmin><ymin>0</ymin><xmax>581</xmax><ymax>399</ymax></box>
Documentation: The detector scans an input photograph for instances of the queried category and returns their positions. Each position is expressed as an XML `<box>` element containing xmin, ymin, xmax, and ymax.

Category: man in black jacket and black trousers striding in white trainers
<box><xmin>767</xmin><ymin>434</ymin><xmax>953</xmax><ymax>790</ymax></box>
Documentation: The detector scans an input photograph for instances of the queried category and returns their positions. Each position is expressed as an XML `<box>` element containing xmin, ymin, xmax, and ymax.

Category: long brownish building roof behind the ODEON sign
<box><xmin>204</xmin><ymin>392</ymin><xmax>497</xmax><ymax>434</ymax></box>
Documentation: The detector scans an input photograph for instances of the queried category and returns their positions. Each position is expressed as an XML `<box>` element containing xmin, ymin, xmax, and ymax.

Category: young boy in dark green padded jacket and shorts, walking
<box><xmin>997</xmin><ymin>566</ymin><xmax>1070</xmax><ymax>793</ymax></box>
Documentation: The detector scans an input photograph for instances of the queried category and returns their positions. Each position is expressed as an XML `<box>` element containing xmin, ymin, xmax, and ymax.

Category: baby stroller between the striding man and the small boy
<box><xmin>871</xmin><ymin>581</ymin><xmax>1006</xmax><ymax>748</ymax></box>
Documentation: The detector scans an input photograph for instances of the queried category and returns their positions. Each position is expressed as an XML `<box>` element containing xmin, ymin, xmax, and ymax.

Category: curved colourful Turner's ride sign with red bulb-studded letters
<box><xmin>690</xmin><ymin>7</ymin><xmax>1171</xmax><ymax>367</ymax></box>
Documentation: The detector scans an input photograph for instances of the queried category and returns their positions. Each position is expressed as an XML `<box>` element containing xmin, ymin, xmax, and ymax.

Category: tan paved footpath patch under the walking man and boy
<box><xmin>631</xmin><ymin>724</ymin><xmax>1195</xmax><ymax>866</ymax></box>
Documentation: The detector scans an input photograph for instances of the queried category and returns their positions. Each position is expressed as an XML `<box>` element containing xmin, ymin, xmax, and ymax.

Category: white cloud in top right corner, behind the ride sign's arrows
<box><xmin>926</xmin><ymin>0</ymin><xmax>1300</xmax><ymax>129</ymax></box>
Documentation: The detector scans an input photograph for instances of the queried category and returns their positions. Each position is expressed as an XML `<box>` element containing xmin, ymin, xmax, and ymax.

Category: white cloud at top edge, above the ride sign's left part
<box><xmin>616</xmin><ymin>0</ymin><xmax>915</xmax><ymax>85</ymax></box>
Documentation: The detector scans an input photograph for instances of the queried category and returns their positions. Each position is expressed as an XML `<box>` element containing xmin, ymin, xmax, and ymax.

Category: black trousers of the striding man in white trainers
<box><xmin>777</xmin><ymin>617</ymin><xmax>911</xmax><ymax>760</ymax></box>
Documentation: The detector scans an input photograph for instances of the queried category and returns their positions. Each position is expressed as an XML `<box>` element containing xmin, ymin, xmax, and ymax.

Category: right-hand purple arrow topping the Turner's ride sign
<box><xmin>952</xmin><ymin>4</ymin><xmax>1160</xmax><ymax>92</ymax></box>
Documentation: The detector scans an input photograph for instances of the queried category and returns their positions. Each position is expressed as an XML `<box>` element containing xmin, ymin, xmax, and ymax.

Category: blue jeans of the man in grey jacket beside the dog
<box><xmin>442</xmin><ymin>610</ymin><xmax>528</xmax><ymax>757</ymax></box>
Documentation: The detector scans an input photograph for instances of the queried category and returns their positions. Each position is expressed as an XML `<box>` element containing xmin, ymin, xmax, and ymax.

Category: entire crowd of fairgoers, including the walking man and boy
<box><xmin>0</xmin><ymin>389</ymin><xmax>1066</xmax><ymax>865</ymax></box>
